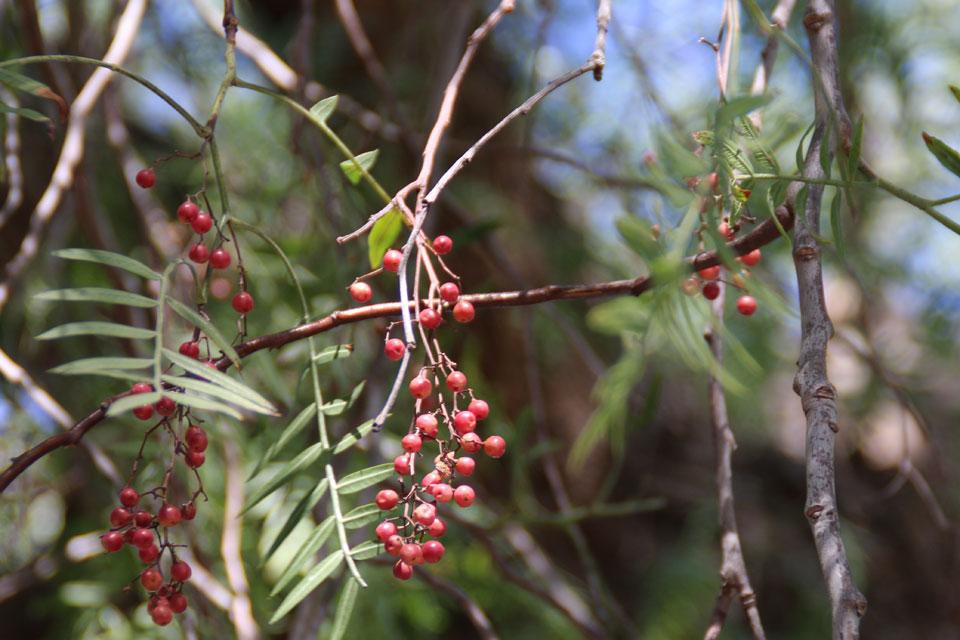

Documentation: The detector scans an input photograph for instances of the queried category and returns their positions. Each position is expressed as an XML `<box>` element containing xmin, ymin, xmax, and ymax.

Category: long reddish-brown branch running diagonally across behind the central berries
<box><xmin>0</xmin><ymin>212</ymin><xmax>793</xmax><ymax>493</ymax></box>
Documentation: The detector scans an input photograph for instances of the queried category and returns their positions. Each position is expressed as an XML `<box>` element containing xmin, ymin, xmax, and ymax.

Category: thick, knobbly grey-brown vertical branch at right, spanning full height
<box><xmin>788</xmin><ymin>0</ymin><xmax>867</xmax><ymax>640</ymax></box>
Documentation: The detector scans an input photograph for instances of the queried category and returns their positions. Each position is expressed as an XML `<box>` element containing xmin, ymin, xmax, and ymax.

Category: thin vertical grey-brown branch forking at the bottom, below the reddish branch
<box><xmin>703</xmin><ymin>283</ymin><xmax>766</xmax><ymax>640</ymax></box>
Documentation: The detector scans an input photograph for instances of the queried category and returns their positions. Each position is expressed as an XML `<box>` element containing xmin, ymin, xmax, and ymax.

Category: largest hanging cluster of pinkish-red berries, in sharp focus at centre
<box><xmin>350</xmin><ymin>236</ymin><xmax>507</xmax><ymax>580</ymax></box>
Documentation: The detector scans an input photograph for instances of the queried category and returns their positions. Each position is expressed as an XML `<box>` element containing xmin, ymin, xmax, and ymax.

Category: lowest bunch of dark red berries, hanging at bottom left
<box><xmin>100</xmin><ymin>487</ymin><xmax>197</xmax><ymax>626</ymax></box>
